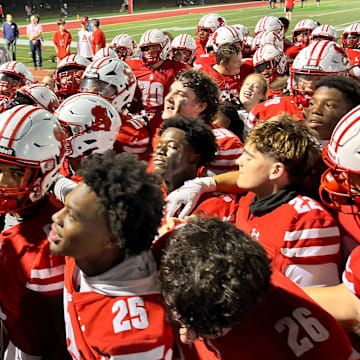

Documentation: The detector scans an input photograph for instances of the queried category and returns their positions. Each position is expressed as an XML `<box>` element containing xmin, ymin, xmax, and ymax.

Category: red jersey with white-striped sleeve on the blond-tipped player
<box><xmin>235</xmin><ymin>192</ymin><xmax>341</xmax><ymax>286</ymax></box>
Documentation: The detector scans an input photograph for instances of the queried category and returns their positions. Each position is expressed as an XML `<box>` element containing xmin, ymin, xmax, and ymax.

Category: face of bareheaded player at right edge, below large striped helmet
<box><xmin>306</xmin><ymin>86</ymin><xmax>351</xmax><ymax>140</ymax></box>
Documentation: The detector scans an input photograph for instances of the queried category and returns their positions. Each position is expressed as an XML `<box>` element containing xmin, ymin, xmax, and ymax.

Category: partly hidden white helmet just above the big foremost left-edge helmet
<box><xmin>15</xmin><ymin>84</ymin><xmax>60</xmax><ymax>113</ymax></box>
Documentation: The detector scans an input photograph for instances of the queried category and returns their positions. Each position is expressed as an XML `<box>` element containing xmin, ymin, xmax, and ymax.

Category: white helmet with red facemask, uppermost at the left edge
<box><xmin>0</xmin><ymin>61</ymin><xmax>34</xmax><ymax>95</ymax></box>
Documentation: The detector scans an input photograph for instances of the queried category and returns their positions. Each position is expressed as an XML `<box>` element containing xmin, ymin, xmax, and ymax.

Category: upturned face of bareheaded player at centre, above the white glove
<box><xmin>154</xmin><ymin>128</ymin><xmax>198</xmax><ymax>184</ymax></box>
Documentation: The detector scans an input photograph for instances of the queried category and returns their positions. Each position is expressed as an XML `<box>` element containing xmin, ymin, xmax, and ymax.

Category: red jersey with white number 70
<box><xmin>127</xmin><ymin>59</ymin><xmax>190</xmax><ymax>113</ymax></box>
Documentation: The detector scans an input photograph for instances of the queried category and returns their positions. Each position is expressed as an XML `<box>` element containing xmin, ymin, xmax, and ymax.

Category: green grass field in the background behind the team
<box><xmin>12</xmin><ymin>0</ymin><xmax>360</xmax><ymax>69</ymax></box>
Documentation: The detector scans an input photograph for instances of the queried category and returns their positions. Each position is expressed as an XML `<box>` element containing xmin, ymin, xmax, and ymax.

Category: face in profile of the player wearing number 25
<box><xmin>49</xmin><ymin>183</ymin><xmax>109</xmax><ymax>267</ymax></box>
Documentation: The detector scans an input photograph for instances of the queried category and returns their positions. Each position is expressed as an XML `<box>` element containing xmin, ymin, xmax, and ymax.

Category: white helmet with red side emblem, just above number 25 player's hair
<box><xmin>55</xmin><ymin>93</ymin><xmax>121</xmax><ymax>160</ymax></box>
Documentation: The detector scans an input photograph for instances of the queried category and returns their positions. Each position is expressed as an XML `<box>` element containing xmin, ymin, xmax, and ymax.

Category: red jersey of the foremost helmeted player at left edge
<box><xmin>0</xmin><ymin>195</ymin><xmax>64</xmax><ymax>355</ymax></box>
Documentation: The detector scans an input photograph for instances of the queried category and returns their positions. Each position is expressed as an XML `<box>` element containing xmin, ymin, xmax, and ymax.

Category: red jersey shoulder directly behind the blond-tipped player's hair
<box><xmin>247</xmin><ymin>96</ymin><xmax>304</xmax><ymax>129</ymax></box>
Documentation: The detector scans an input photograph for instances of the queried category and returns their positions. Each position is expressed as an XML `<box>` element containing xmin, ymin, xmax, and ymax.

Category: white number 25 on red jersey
<box><xmin>112</xmin><ymin>297</ymin><xmax>149</xmax><ymax>334</ymax></box>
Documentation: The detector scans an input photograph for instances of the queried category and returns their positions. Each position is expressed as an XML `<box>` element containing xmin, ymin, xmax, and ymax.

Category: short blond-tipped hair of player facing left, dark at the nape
<box><xmin>245</xmin><ymin>114</ymin><xmax>321</xmax><ymax>184</ymax></box>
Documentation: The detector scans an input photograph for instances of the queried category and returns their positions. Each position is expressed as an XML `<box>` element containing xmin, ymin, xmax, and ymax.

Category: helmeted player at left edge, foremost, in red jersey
<box><xmin>0</xmin><ymin>105</ymin><xmax>67</xmax><ymax>360</ymax></box>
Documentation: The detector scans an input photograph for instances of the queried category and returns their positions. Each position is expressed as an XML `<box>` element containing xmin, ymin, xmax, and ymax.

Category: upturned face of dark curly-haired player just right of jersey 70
<box><xmin>162</xmin><ymin>81</ymin><xmax>207</xmax><ymax>120</ymax></box>
